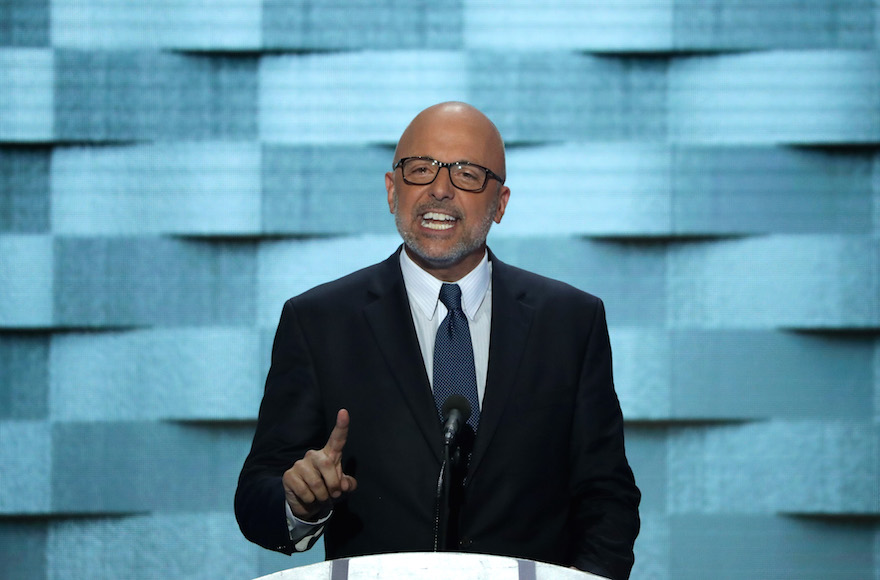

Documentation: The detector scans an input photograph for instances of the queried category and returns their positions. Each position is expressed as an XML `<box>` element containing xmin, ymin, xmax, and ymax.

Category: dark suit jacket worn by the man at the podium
<box><xmin>235</xmin><ymin>250</ymin><xmax>640</xmax><ymax>578</ymax></box>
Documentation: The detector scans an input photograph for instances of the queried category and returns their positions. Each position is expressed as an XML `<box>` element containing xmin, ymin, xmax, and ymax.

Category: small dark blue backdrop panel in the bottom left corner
<box><xmin>0</xmin><ymin>519</ymin><xmax>49</xmax><ymax>580</ymax></box>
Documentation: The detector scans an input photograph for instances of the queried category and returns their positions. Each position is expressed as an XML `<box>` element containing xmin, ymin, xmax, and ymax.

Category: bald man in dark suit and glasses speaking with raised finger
<box><xmin>235</xmin><ymin>103</ymin><xmax>640</xmax><ymax>578</ymax></box>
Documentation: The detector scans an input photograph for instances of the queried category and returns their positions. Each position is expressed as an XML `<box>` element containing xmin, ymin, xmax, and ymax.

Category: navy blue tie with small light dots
<box><xmin>434</xmin><ymin>284</ymin><xmax>480</xmax><ymax>432</ymax></box>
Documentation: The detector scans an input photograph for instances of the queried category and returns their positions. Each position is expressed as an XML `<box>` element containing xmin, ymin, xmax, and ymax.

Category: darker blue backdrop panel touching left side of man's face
<box><xmin>262</xmin><ymin>145</ymin><xmax>395</xmax><ymax>235</ymax></box>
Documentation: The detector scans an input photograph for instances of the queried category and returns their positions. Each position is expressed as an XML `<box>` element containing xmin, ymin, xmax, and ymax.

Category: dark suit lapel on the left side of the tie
<box><xmin>364</xmin><ymin>250</ymin><xmax>441</xmax><ymax>463</ymax></box>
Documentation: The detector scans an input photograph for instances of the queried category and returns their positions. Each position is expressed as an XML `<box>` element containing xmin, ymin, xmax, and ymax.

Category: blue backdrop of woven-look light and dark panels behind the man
<box><xmin>0</xmin><ymin>0</ymin><xmax>880</xmax><ymax>580</ymax></box>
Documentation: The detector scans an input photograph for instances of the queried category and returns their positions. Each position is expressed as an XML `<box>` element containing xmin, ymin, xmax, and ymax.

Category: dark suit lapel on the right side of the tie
<box><xmin>469</xmin><ymin>252</ymin><xmax>534</xmax><ymax>474</ymax></box>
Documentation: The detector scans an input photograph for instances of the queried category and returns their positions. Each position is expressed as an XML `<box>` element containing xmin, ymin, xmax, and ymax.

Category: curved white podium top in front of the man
<box><xmin>255</xmin><ymin>552</ymin><xmax>603</xmax><ymax>580</ymax></box>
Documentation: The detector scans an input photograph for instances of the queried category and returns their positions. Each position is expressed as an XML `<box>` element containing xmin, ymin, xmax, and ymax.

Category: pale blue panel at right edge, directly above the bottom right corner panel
<box><xmin>667</xmin><ymin>420</ymin><xmax>880</xmax><ymax>516</ymax></box>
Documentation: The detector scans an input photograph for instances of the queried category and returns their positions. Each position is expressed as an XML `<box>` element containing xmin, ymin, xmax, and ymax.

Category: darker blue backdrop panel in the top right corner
<box><xmin>674</xmin><ymin>0</ymin><xmax>875</xmax><ymax>51</ymax></box>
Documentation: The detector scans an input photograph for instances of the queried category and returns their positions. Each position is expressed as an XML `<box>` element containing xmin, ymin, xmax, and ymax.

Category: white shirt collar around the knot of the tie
<box><xmin>400</xmin><ymin>248</ymin><xmax>492</xmax><ymax>320</ymax></box>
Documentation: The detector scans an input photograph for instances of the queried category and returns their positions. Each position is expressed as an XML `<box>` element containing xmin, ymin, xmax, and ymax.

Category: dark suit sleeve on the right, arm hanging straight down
<box><xmin>571</xmin><ymin>299</ymin><xmax>641</xmax><ymax>580</ymax></box>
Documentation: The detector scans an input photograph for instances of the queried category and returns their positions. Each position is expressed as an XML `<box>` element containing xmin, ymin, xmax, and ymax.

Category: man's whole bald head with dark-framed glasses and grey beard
<box><xmin>385</xmin><ymin>102</ymin><xmax>510</xmax><ymax>281</ymax></box>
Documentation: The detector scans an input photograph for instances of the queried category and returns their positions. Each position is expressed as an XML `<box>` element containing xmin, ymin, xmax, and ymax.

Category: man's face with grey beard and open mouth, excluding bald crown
<box><xmin>385</xmin><ymin>110</ymin><xmax>510</xmax><ymax>280</ymax></box>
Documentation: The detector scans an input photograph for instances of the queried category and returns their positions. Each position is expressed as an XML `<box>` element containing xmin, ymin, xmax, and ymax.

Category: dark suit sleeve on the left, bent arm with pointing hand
<box><xmin>235</xmin><ymin>301</ymin><xmax>328</xmax><ymax>554</ymax></box>
